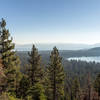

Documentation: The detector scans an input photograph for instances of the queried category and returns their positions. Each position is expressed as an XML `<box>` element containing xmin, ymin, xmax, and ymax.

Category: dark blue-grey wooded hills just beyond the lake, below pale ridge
<box><xmin>17</xmin><ymin>47</ymin><xmax>100</xmax><ymax>60</ymax></box>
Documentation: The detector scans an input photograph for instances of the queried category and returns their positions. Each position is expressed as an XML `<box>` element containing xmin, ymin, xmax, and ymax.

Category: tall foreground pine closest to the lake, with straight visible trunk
<box><xmin>48</xmin><ymin>47</ymin><xmax>65</xmax><ymax>100</ymax></box>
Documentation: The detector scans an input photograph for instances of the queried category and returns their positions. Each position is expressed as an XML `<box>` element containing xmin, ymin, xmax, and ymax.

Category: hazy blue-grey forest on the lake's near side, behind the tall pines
<box><xmin>17</xmin><ymin>51</ymin><xmax>100</xmax><ymax>86</ymax></box>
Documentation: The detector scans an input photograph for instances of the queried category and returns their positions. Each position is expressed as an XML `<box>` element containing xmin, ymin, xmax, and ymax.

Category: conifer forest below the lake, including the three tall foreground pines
<box><xmin>0</xmin><ymin>19</ymin><xmax>100</xmax><ymax>100</ymax></box>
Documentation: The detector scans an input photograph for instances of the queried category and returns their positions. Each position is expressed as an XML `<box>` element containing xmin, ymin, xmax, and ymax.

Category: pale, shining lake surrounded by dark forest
<box><xmin>68</xmin><ymin>56</ymin><xmax>100</xmax><ymax>62</ymax></box>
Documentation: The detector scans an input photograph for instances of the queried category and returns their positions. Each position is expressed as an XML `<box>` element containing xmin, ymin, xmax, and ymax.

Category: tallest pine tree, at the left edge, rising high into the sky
<box><xmin>0</xmin><ymin>19</ymin><xmax>20</xmax><ymax>94</ymax></box>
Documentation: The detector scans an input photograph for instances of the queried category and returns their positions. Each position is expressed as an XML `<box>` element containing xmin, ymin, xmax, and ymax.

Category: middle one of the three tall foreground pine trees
<box><xmin>28</xmin><ymin>45</ymin><xmax>44</xmax><ymax>100</ymax></box>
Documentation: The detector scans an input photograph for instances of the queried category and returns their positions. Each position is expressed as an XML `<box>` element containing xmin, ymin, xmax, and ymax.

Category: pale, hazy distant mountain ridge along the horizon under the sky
<box><xmin>16</xmin><ymin>43</ymin><xmax>100</xmax><ymax>51</ymax></box>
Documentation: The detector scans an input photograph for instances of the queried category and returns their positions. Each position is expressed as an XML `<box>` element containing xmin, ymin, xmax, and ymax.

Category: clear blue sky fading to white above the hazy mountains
<box><xmin>0</xmin><ymin>0</ymin><xmax>100</xmax><ymax>44</ymax></box>
